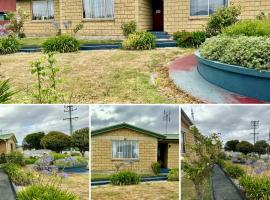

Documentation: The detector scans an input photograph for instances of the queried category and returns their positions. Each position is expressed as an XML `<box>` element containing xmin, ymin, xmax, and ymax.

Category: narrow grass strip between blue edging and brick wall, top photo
<box><xmin>20</xmin><ymin>37</ymin><xmax>121</xmax><ymax>47</ymax></box>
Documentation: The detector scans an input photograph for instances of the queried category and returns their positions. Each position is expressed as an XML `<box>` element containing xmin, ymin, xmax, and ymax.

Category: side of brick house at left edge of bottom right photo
<box><xmin>181</xmin><ymin>109</ymin><xmax>194</xmax><ymax>157</ymax></box>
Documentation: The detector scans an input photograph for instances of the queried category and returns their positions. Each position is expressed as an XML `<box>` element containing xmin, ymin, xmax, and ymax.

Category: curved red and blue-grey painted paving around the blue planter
<box><xmin>169</xmin><ymin>54</ymin><xmax>265</xmax><ymax>104</ymax></box>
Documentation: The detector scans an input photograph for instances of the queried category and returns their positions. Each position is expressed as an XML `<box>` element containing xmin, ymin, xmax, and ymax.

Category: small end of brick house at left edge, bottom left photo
<box><xmin>0</xmin><ymin>133</ymin><xmax>17</xmax><ymax>155</ymax></box>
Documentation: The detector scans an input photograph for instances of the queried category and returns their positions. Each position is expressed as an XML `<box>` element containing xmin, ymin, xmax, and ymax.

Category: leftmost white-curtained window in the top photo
<box><xmin>32</xmin><ymin>0</ymin><xmax>54</xmax><ymax>20</ymax></box>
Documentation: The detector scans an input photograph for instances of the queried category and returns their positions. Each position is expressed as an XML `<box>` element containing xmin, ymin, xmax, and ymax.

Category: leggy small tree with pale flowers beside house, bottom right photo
<box><xmin>182</xmin><ymin>126</ymin><xmax>222</xmax><ymax>200</ymax></box>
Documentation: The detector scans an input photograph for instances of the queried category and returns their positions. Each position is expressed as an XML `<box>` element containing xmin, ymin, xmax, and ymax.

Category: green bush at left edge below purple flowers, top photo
<box><xmin>0</xmin><ymin>36</ymin><xmax>20</xmax><ymax>54</ymax></box>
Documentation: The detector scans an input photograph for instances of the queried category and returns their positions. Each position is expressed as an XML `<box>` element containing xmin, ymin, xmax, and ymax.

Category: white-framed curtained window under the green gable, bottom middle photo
<box><xmin>112</xmin><ymin>140</ymin><xmax>139</xmax><ymax>160</ymax></box>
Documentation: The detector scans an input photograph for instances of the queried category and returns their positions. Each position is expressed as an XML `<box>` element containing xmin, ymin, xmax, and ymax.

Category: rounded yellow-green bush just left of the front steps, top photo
<box><xmin>122</xmin><ymin>32</ymin><xmax>156</xmax><ymax>50</ymax></box>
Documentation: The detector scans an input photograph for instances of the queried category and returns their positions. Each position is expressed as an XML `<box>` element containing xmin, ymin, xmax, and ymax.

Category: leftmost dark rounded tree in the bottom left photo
<box><xmin>23</xmin><ymin>132</ymin><xmax>45</xmax><ymax>149</ymax></box>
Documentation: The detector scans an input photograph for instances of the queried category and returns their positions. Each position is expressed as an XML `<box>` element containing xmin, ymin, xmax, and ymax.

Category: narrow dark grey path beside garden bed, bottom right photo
<box><xmin>212</xmin><ymin>165</ymin><xmax>243</xmax><ymax>200</ymax></box>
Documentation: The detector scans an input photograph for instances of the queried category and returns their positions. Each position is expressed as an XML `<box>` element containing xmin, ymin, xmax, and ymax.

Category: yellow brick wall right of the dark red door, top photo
<box><xmin>164</xmin><ymin>0</ymin><xmax>270</xmax><ymax>33</ymax></box>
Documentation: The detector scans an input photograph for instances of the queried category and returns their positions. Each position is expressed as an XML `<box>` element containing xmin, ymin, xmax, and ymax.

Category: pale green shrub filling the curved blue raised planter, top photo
<box><xmin>200</xmin><ymin>36</ymin><xmax>270</xmax><ymax>70</ymax></box>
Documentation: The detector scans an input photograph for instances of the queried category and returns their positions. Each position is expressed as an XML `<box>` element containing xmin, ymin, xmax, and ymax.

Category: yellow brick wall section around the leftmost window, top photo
<box><xmin>17</xmin><ymin>0</ymin><xmax>60</xmax><ymax>36</ymax></box>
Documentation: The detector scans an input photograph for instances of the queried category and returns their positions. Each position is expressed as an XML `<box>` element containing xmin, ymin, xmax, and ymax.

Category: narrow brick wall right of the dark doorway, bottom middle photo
<box><xmin>168</xmin><ymin>142</ymin><xmax>179</xmax><ymax>169</ymax></box>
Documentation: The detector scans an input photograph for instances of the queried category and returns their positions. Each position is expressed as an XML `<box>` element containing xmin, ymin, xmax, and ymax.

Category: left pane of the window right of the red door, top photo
<box><xmin>190</xmin><ymin>0</ymin><xmax>208</xmax><ymax>16</ymax></box>
